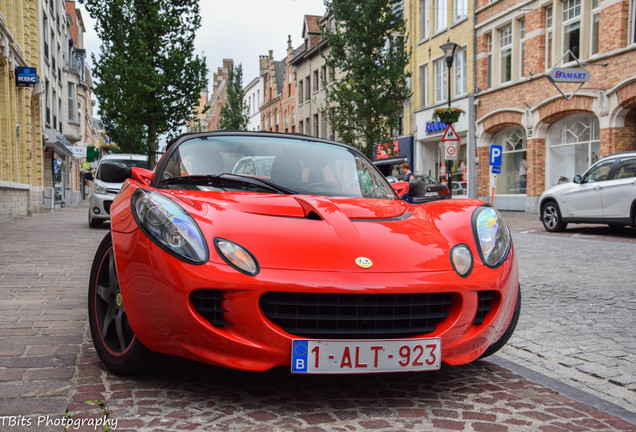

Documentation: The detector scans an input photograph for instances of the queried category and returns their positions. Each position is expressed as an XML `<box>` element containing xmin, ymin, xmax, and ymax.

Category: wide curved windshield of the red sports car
<box><xmin>157</xmin><ymin>136</ymin><xmax>396</xmax><ymax>199</ymax></box>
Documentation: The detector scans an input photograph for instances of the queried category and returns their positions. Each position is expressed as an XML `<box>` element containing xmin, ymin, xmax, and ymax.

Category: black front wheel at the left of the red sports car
<box><xmin>88</xmin><ymin>231</ymin><xmax>150</xmax><ymax>375</ymax></box>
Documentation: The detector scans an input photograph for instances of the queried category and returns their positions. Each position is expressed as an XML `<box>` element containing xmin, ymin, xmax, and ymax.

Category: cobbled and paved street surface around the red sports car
<box><xmin>0</xmin><ymin>207</ymin><xmax>636</xmax><ymax>432</ymax></box>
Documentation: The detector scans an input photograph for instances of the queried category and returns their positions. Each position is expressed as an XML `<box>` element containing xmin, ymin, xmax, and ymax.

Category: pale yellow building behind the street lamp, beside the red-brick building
<box><xmin>404</xmin><ymin>0</ymin><xmax>476</xmax><ymax>196</ymax></box>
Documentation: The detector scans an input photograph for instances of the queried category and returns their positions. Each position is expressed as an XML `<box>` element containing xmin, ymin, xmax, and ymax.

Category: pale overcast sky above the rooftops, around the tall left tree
<box><xmin>76</xmin><ymin>0</ymin><xmax>325</xmax><ymax>88</ymax></box>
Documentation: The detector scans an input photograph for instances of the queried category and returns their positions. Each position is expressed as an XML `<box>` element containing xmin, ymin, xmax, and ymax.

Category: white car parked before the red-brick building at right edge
<box><xmin>539</xmin><ymin>151</ymin><xmax>636</xmax><ymax>232</ymax></box>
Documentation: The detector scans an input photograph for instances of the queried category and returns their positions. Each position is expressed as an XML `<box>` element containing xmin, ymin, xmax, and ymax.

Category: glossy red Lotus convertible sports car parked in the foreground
<box><xmin>89</xmin><ymin>132</ymin><xmax>521</xmax><ymax>375</ymax></box>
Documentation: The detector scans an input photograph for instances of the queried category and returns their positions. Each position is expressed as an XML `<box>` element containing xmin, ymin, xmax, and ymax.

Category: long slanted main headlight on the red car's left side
<box><xmin>130</xmin><ymin>189</ymin><xmax>209</xmax><ymax>264</ymax></box>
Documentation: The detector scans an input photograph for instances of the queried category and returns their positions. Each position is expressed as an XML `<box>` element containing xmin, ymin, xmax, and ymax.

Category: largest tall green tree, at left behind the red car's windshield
<box><xmin>80</xmin><ymin>0</ymin><xmax>208</xmax><ymax>167</ymax></box>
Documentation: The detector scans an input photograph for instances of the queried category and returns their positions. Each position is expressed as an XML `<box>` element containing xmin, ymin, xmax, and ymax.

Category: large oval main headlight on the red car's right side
<box><xmin>472</xmin><ymin>206</ymin><xmax>512</xmax><ymax>268</ymax></box>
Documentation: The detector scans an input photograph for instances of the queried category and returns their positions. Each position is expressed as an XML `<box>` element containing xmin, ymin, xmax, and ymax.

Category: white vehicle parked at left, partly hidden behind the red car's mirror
<box><xmin>88</xmin><ymin>153</ymin><xmax>148</xmax><ymax>228</ymax></box>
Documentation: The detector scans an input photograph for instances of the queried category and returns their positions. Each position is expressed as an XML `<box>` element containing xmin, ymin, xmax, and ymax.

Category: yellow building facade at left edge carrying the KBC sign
<box><xmin>0</xmin><ymin>0</ymin><xmax>43</xmax><ymax>221</ymax></box>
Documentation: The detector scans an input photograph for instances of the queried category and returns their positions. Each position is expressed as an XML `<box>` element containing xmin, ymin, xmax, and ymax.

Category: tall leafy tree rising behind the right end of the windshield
<box><xmin>323</xmin><ymin>0</ymin><xmax>411</xmax><ymax>157</ymax></box>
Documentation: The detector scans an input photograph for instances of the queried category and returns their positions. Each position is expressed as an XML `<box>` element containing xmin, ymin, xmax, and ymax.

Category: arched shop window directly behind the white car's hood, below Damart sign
<box><xmin>545</xmin><ymin>114</ymin><xmax>600</xmax><ymax>189</ymax></box>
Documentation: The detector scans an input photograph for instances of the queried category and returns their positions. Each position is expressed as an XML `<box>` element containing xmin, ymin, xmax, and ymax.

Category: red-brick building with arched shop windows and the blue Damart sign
<box><xmin>475</xmin><ymin>0</ymin><xmax>636</xmax><ymax>212</ymax></box>
